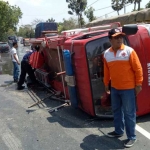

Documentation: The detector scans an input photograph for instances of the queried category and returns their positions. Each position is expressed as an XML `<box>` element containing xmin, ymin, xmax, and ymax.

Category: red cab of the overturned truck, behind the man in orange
<box><xmin>64</xmin><ymin>24</ymin><xmax>150</xmax><ymax>117</ymax></box>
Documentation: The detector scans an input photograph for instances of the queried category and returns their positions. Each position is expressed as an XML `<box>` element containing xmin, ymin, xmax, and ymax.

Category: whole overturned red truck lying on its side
<box><xmin>30</xmin><ymin>22</ymin><xmax>150</xmax><ymax>117</ymax></box>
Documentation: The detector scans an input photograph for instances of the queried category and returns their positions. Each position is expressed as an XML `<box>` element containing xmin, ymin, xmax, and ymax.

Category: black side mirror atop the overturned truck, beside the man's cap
<box><xmin>122</xmin><ymin>24</ymin><xmax>138</xmax><ymax>35</ymax></box>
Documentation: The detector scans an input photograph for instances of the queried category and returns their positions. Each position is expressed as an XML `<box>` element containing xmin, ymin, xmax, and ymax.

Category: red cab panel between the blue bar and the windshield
<box><xmin>64</xmin><ymin>40</ymin><xmax>95</xmax><ymax>116</ymax></box>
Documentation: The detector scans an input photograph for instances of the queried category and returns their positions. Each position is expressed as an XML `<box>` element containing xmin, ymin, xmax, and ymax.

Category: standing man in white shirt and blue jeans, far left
<box><xmin>10</xmin><ymin>42</ymin><xmax>20</xmax><ymax>82</ymax></box>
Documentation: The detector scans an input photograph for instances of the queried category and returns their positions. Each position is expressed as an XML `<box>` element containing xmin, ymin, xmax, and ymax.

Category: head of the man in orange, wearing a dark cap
<box><xmin>108</xmin><ymin>28</ymin><xmax>125</xmax><ymax>49</ymax></box>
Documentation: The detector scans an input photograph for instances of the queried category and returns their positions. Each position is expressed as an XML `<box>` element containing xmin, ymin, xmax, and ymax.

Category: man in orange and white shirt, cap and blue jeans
<box><xmin>104</xmin><ymin>29</ymin><xmax>143</xmax><ymax>147</ymax></box>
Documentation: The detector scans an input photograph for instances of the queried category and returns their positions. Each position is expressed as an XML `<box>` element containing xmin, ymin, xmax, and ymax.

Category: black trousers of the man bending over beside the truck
<box><xmin>18</xmin><ymin>60</ymin><xmax>36</xmax><ymax>86</ymax></box>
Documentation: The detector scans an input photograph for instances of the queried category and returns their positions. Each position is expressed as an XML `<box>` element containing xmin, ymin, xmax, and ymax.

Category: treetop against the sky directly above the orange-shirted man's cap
<box><xmin>111</xmin><ymin>0</ymin><xmax>125</xmax><ymax>15</ymax></box>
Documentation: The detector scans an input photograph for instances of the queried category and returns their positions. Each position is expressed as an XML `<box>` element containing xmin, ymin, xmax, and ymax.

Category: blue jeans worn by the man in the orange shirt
<box><xmin>111</xmin><ymin>87</ymin><xmax>136</xmax><ymax>140</ymax></box>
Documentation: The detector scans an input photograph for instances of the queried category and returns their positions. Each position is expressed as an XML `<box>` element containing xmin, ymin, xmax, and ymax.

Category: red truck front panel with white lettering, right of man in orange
<box><xmin>128</xmin><ymin>27</ymin><xmax>150</xmax><ymax>115</ymax></box>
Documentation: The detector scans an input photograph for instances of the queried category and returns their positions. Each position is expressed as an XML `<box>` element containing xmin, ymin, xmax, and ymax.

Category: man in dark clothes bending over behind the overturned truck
<box><xmin>17</xmin><ymin>45</ymin><xmax>40</xmax><ymax>90</ymax></box>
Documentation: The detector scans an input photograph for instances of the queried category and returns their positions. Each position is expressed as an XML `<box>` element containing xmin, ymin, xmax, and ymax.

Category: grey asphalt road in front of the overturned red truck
<box><xmin>0</xmin><ymin>41</ymin><xmax>150</xmax><ymax>150</ymax></box>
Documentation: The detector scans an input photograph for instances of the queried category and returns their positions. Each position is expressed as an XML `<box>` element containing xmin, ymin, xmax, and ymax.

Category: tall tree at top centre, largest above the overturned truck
<box><xmin>66</xmin><ymin>0</ymin><xmax>87</xmax><ymax>27</ymax></box>
